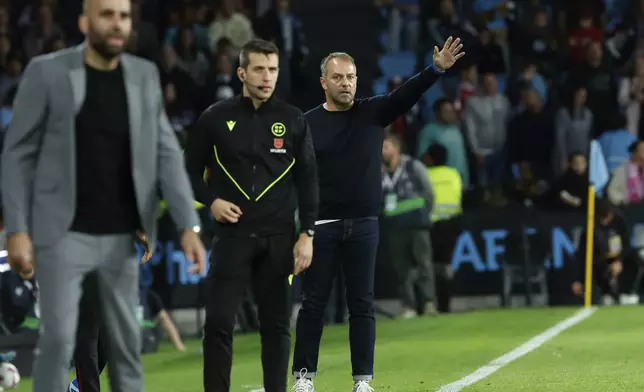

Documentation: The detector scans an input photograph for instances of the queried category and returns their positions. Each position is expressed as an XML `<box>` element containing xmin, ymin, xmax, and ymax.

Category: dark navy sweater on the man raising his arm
<box><xmin>305</xmin><ymin>67</ymin><xmax>442</xmax><ymax>220</ymax></box>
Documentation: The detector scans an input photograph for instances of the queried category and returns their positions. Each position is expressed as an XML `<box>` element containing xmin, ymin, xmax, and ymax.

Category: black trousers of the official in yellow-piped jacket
<box><xmin>203</xmin><ymin>234</ymin><xmax>294</xmax><ymax>392</ymax></box>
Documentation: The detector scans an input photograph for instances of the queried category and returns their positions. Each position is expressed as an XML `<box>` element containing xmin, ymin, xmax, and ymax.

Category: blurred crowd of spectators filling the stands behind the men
<box><xmin>0</xmin><ymin>0</ymin><xmax>644</xmax><ymax>336</ymax></box>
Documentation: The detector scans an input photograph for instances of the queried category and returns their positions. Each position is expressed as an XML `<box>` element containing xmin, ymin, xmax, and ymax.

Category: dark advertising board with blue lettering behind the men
<box><xmin>0</xmin><ymin>206</ymin><xmax>644</xmax><ymax>309</ymax></box>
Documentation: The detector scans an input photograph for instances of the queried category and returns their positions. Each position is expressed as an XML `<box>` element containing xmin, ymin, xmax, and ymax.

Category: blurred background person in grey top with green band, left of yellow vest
<box><xmin>382</xmin><ymin>134</ymin><xmax>436</xmax><ymax>318</ymax></box>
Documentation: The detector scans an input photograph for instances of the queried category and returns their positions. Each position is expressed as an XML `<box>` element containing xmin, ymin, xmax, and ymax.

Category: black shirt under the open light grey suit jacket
<box><xmin>71</xmin><ymin>66</ymin><xmax>140</xmax><ymax>234</ymax></box>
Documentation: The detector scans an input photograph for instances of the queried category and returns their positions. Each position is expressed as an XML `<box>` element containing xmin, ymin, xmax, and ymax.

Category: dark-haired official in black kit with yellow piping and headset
<box><xmin>185</xmin><ymin>40</ymin><xmax>318</xmax><ymax>392</ymax></box>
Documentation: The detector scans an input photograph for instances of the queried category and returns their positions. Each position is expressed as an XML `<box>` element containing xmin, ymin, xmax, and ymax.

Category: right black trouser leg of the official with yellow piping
<box><xmin>252</xmin><ymin>234</ymin><xmax>294</xmax><ymax>392</ymax></box>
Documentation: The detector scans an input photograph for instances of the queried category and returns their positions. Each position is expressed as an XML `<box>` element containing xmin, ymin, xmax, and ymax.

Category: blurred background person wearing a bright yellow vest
<box><xmin>425</xmin><ymin>144</ymin><xmax>463</xmax><ymax>313</ymax></box>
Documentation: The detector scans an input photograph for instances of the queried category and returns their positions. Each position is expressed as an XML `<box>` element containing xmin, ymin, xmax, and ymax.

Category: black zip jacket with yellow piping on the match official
<box><xmin>185</xmin><ymin>97</ymin><xmax>318</xmax><ymax>236</ymax></box>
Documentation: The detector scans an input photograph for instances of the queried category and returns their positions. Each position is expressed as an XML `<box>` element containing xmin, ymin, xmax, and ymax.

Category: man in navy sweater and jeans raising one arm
<box><xmin>293</xmin><ymin>37</ymin><xmax>464</xmax><ymax>392</ymax></box>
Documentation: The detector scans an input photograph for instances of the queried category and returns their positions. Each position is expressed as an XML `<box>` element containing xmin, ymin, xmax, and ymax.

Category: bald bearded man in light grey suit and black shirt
<box><xmin>1</xmin><ymin>0</ymin><xmax>205</xmax><ymax>392</ymax></box>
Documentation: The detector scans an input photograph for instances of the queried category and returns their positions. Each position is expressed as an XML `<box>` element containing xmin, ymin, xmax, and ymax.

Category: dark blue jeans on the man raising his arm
<box><xmin>293</xmin><ymin>218</ymin><xmax>379</xmax><ymax>380</ymax></box>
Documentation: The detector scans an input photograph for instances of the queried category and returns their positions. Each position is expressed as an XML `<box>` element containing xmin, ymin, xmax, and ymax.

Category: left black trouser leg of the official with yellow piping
<box><xmin>203</xmin><ymin>237</ymin><xmax>260</xmax><ymax>392</ymax></box>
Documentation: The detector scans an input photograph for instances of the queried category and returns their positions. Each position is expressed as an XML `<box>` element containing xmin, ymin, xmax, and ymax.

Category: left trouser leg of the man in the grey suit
<box><xmin>33</xmin><ymin>233</ymin><xmax>100</xmax><ymax>392</ymax></box>
